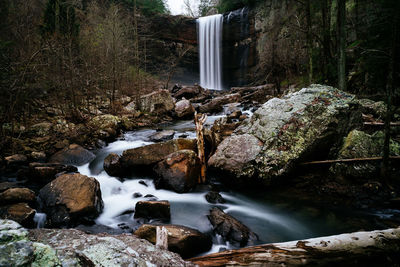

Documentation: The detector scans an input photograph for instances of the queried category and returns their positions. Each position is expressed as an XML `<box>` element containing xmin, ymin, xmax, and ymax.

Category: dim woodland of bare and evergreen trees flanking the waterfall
<box><xmin>0</xmin><ymin>0</ymin><xmax>400</xmax><ymax>153</ymax></box>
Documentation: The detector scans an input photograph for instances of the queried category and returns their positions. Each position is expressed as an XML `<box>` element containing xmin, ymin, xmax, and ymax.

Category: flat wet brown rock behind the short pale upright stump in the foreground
<box><xmin>134</xmin><ymin>224</ymin><xmax>212</xmax><ymax>258</ymax></box>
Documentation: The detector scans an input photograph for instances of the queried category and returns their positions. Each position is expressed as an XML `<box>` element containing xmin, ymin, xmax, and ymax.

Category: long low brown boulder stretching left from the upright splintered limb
<box><xmin>106</xmin><ymin>138</ymin><xmax>197</xmax><ymax>176</ymax></box>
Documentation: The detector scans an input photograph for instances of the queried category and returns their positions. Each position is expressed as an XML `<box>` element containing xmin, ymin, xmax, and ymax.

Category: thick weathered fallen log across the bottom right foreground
<box><xmin>189</xmin><ymin>228</ymin><xmax>400</xmax><ymax>266</ymax></box>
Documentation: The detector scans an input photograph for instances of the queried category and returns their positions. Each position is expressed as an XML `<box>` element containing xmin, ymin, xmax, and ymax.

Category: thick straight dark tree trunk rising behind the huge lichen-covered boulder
<box><xmin>337</xmin><ymin>0</ymin><xmax>346</xmax><ymax>91</ymax></box>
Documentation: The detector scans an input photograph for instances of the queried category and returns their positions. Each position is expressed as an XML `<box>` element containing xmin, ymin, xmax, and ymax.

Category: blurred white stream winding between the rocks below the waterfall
<box><xmin>78</xmin><ymin>114</ymin><xmax>399</xmax><ymax>254</ymax></box>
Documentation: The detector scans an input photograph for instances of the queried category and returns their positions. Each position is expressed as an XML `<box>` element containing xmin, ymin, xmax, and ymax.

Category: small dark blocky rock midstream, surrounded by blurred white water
<box><xmin>134</xmin><ymin>200</ymin><xmax>171</xmax><ymax>221</ymax></box>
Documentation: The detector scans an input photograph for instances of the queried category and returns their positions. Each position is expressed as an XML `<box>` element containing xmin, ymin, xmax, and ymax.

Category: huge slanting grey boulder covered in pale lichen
<box><xmin>208</xmin><ymin>85</ymin><xmax>362</xmax><ymax>185</ymax></box>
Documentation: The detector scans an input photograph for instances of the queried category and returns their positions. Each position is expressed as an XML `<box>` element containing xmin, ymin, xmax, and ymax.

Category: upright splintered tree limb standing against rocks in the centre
<box><xmin>194</xmin><ymin>112</ymin><xmax>207</xmax><ymax>183</ymax></box>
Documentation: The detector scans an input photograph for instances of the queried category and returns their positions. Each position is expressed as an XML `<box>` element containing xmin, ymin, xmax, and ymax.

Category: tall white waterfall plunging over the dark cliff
<box><xmin>198</xmin><ymin>14</ymin><xmax>223</xmax><ymax>90</ymax></box>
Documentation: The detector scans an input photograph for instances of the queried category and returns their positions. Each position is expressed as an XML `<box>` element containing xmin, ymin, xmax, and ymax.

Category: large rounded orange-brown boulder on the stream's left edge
<box><xmin>39</xmin><ymin>173</ymin><xmax>103</xmax><ymax>226</ymax></box>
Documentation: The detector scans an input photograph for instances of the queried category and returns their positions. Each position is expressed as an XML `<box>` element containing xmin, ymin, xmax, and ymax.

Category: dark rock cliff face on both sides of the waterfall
<box><xmin>146</xmin><ymin>0</ymin><xmax>306</xmax><ymax>89</ymax></box>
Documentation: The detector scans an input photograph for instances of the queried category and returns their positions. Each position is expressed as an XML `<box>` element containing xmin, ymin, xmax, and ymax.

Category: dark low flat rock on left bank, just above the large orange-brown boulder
<box><xmin>25</xmin><ymin>162</ymin><xmax>78</xmax><ymax>184</ymax></box>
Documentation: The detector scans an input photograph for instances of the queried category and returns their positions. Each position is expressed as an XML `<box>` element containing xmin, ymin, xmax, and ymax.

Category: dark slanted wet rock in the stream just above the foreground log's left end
<box><xmin>207</xmin><ymin>208</ymin><xmax>258</xmax><ymax>247</ymax></box>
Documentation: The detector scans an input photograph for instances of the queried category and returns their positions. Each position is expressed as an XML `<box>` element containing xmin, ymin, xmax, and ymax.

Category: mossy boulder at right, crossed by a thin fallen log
<box><xmin>330</xmin><ymin>130</ymin><xmax>400</xmax><ymax>181</ymax></box>
